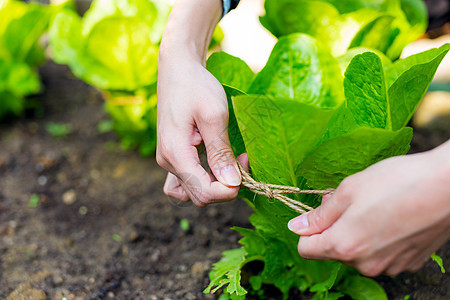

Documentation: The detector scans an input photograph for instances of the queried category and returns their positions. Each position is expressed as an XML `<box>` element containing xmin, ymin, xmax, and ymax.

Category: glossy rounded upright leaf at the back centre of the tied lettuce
<box><xmin>248</xmin><ymin>34</ymin><xmax>344</xmax><ymax>107</ymax></box>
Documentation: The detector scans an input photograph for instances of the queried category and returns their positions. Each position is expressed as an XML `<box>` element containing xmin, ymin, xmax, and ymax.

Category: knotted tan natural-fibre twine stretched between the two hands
<box><xmin>237</xmin><ymin>163</ymin><xmax>334</xmax><ymax>213</ymax></box>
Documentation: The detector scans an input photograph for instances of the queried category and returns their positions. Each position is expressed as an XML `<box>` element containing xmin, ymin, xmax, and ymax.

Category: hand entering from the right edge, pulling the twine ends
<box><xmin>288</xmin><ymin>142</ymin><xmax>450</xmax><ymax>276</ymax></box>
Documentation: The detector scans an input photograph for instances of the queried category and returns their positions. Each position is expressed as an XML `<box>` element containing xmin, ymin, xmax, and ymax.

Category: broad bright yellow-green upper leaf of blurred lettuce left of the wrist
<box><xmin>50</xmin><ymin>0</ymin><xmax>168</xmax><ymax>91</ymax></box>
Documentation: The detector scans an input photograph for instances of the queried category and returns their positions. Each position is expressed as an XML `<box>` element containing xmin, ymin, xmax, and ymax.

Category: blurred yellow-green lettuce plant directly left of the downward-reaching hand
<box><xmin>49</xmin><ymin>0</ymin><xmax>223</xmax><ymax>156</ymax></box>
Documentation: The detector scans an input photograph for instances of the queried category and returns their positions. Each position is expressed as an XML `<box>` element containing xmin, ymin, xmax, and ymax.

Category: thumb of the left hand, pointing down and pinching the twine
<box><xmin>197</xmin><ymin>113</ymin><xmax>241</xmax><ymax>187</ymax></box>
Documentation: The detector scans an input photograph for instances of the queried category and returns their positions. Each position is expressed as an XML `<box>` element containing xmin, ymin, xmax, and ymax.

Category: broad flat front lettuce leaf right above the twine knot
<box><xmin>233</xmin><ymin>96</ymin><xmax>332</xmax><ymax>186</ymax></box>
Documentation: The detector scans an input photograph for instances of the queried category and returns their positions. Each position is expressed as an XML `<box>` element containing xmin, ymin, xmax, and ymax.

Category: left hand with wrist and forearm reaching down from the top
<box><xmin>156</xmin><ymin>0</ymin><xmax>246</xmax><ymax>206</ymax></box>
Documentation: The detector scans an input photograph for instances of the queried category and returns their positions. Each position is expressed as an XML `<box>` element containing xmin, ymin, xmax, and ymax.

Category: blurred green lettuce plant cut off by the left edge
<box><xmin>0</xmin><ymin>0</ymin><xmax>52</xmax><ymax>120</ymax></box>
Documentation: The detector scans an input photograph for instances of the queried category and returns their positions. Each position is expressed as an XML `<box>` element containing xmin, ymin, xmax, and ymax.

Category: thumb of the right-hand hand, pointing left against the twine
<box><xmin>288</xmin><ymin>194</ymin><xmax>347</xmax><ymax>235</ymax></box>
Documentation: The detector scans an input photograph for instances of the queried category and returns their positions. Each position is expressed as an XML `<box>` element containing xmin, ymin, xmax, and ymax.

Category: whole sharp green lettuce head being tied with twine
<box><xmin>205</xmin><ymin>33</ymin><xmax>450</xmax><ymax>299</ymax></box>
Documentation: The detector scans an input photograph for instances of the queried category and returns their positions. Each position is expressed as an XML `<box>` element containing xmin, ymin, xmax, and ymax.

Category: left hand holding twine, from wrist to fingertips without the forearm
<box><xmin>156</xmin><ymin>56</ymin><xmax>247</xmax><ymax>207</ymax></box>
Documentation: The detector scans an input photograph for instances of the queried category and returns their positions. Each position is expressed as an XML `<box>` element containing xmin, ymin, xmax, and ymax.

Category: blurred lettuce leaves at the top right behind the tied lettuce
<box><xmin>260</xmin><ymin>0</ymin><xmax>428</xmax><ymax>60</ymax></box>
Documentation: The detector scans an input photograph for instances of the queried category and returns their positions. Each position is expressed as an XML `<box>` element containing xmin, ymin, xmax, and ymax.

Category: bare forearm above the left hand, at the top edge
<box><xmin>160</xmin><ymin>0</ymin><xmax>223</xmax><ymax>64</ymax></box>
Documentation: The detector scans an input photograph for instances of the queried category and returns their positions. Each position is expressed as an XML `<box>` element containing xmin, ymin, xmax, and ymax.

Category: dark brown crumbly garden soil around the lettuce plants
<box><xmin>0</xmin><ymin>63</ymin><xmax>450</xmax><ymax>299</ymax></box>
